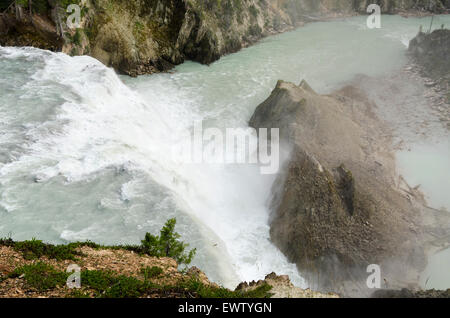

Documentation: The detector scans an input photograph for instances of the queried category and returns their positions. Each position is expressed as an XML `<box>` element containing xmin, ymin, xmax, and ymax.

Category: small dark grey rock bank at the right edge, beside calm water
<box><xmin>409</xmin><ymin>28</ymin><xmax>450</xmax><ymax>104</ymax></box>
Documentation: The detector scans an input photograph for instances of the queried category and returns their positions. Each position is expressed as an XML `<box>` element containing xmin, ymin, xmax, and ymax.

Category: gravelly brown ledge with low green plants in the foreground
<box><xmin>0</xmin><ymin>240</ymin><xmax>337</xmax><ymax>298</ymax></box>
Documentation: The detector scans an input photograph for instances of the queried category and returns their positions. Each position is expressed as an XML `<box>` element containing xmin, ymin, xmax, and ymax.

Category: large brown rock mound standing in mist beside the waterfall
<box><xmin>250</xmin><ymin>81</ymin><xmax>426</xmax><ymax>296</ymax></box>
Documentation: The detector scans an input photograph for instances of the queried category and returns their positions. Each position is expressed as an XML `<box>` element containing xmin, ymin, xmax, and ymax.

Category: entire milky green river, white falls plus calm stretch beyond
<box><xmin>0</xmin><ymin>16</ymin><xmax>450</xmax><ymax>287</ymax></box>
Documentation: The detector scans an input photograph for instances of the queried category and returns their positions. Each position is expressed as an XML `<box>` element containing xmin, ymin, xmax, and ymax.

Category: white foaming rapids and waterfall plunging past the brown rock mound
<box><xmin>0</xmin><ymin>48</ymin><xmax>301</xmax><ymax>286</ymax></box>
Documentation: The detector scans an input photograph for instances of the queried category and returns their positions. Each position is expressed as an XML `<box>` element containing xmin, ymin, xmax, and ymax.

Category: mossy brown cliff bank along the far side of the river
<box><xmin>0</xmin><ymin>0</ymin><xmax>450</xmax><ymax>76</ymax></box>
